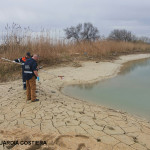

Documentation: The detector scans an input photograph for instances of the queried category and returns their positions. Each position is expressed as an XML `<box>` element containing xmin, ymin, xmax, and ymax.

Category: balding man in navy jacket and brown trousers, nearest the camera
<box><xmin>24</xmin><ymin>54</ymin><xmax>39</xmax><ymax>102</ymax></box>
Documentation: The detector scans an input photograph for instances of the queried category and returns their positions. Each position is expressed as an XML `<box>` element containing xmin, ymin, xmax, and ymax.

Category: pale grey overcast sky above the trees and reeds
<box><xmin>0</xmin><ymin>0</ymin><xmax>150</xmax><ymax>37</ymax></box>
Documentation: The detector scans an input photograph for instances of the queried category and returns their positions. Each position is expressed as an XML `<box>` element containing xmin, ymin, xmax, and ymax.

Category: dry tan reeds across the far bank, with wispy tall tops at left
<box><xmin>0</xmin><ymin>24</ymin><xmax>150</xmax><ymax>81</ymax></box>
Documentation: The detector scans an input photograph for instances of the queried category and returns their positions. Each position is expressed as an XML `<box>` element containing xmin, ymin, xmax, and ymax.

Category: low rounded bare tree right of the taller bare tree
<box><xmin>108</xmin><ymin>29</ymin><xmax>135</xmax><ymax>42</ymax></box>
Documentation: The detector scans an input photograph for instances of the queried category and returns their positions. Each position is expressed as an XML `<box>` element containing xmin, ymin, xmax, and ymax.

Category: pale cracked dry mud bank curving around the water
<box><xmin>0</xmin><ymin>54</ymin><xmax>150</xmax><ymax>150</ymax></box>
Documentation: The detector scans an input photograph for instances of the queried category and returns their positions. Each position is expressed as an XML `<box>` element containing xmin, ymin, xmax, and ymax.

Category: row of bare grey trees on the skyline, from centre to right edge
<box><xmin>64</xmin><ymin>23</ymin><xmax>150</xmax><ymax>43</ymax></box>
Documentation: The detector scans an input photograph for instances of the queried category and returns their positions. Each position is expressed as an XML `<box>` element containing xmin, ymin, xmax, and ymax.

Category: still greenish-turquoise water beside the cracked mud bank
<box><xmin>63</xmin><ymin>59</ymin><xmax>150</xmax><ymax>120</ymax></box>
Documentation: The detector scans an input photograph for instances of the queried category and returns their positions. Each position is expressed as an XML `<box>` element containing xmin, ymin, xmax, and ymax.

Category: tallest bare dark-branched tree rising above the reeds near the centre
<box><xmin>64</xmin><ymin>23</ymin><xmax>100</xmax><ymax>42</ymax></box>
